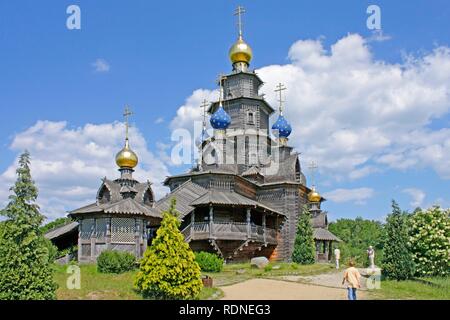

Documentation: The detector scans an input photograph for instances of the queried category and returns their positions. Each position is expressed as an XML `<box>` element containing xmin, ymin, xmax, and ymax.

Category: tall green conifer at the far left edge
<box><xmin>0</xmin><ymin>152</ymin><xmax>56</xmax><ymax>300</ymax></box>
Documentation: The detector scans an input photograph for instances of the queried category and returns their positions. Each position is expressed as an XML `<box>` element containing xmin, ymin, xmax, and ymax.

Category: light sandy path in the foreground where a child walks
<box><xmin>221</xmin><ymin>273</ymin><xmax>367</xmax><ymax>300</ymax></box>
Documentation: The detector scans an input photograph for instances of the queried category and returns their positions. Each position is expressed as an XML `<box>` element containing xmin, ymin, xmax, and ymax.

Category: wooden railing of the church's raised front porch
<box><xmin>182</xmin><ymin>222</ymin><xmax>278</xmax><ymax>244</ymax></box>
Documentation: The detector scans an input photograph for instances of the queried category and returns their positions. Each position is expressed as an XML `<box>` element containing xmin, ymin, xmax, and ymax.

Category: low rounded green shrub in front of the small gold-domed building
<box><xmin>97</xmin><ymin>250</ymin><xmax>136</xmax><ymax>274</ymax></box>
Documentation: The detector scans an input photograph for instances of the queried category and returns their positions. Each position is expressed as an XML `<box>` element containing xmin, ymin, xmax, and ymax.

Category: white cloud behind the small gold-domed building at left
<box><xmin>0</xmin><ymin>121</ymin><xmax>169</xmax><ymax>218</ymax></box>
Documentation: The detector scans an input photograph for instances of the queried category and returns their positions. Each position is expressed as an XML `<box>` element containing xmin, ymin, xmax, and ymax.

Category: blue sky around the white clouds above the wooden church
<box><xmin>0</xmin><ymin>0</ymin><xmax>450</xmax><ymax>219</ymax></box>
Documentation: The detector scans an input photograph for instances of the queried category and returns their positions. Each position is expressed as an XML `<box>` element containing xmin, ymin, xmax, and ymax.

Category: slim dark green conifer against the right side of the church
<box><xmin>292</xmin><ymin>206</ymin><xmax>316</xmax><ymax>264</ymax></box>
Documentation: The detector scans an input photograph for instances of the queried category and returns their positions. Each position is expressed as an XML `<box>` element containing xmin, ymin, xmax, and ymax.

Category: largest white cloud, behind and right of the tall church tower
<box><xmin>172</xmin><ymin>34</ymin><xmax>450</xmax><ymax>181</ymax></box>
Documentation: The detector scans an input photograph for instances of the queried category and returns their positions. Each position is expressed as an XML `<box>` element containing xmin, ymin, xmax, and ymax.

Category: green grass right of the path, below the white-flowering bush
<box><xmin>369</xmin><ymin>278</ymin><xmax>450</xmax><ymax>300</ymax></box>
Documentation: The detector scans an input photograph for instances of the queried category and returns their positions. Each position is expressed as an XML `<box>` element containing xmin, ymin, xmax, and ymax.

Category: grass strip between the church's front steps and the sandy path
<box><xmin>205</xmin><ymin>262</ymin><xmax>334</xmax><ymax>287</ymax></box>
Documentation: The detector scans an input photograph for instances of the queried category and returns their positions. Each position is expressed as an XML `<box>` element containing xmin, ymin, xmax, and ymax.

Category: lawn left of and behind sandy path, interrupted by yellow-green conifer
<box><xmin>55</xmin><ymin>263</ymin><xmax>333</xmax><ymax>300</ymax></box>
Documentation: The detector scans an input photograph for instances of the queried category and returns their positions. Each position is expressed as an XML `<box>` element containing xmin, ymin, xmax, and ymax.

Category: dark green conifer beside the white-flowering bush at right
<box><xmin>382</xmin><ymin>201</ymin><xmax>414</xmax><ymax>280</ymax></box>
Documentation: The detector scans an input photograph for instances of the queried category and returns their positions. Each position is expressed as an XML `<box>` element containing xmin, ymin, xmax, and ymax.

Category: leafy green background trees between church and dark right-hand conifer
<box><xmin>329</xmin><ymin>217</ymin><xmax>384</xmax><ymax>266</ymax></box>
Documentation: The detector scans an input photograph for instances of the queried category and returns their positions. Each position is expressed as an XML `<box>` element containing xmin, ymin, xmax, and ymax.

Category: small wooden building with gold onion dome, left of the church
<box><xmin>69</xmin><ymin>112</ymin><xmax>162</xmax><ymax>263</ymax></box>
